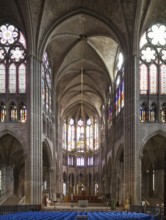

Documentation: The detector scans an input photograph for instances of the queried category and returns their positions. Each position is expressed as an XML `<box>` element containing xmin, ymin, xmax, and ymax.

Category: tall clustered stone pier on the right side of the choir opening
<box><xmin>124</xmin><ymin>56</ymin><xmax>141</xmax><ymax>205</ymax></box>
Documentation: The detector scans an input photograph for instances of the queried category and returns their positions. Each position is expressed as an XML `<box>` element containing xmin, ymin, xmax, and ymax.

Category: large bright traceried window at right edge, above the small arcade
<box><xmin>140</xmin><ymin>24</ymin><xmax>166</xmax><ymax>95</ymax></box>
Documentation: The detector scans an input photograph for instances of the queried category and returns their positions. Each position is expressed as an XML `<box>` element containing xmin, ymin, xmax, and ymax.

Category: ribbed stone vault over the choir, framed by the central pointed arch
<box><xmin>47</xmin><ymin>14</ymin><xmax>118</xmax><ymax>116</ymax></box>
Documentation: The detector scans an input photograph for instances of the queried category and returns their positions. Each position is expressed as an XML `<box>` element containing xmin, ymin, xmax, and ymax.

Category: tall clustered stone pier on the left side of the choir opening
<box><xmin>25</xmin><ymin>56</ymin><xmax>42</xmax><ymax>204</ymax></box>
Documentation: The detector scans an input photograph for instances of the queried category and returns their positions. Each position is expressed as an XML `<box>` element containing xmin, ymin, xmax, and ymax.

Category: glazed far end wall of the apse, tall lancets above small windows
<box><xmin>63</xmin><ymin>117</ymin><xmax>99</xmax><ymax>166</ymax></box>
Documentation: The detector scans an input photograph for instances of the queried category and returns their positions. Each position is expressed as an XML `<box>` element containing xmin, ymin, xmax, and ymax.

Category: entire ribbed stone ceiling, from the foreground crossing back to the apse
<box><xmin>0</xmin><ymin>0</ymin><xmax>166</xmax><ymax>119</ymax></box>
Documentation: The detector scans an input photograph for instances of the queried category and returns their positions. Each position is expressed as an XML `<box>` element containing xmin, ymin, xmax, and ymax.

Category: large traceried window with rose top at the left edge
<box><xmin>0</xmin><ymin>23</ymin><xmax>26</xmax><ymax>93</ymax></box>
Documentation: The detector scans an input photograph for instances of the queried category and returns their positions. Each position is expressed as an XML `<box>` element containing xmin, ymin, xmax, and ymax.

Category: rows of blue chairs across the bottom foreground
<box><xmin>0</xmin><ymin>211</ymin><xmax>155</xmax><ymax>220</ymax></box>
